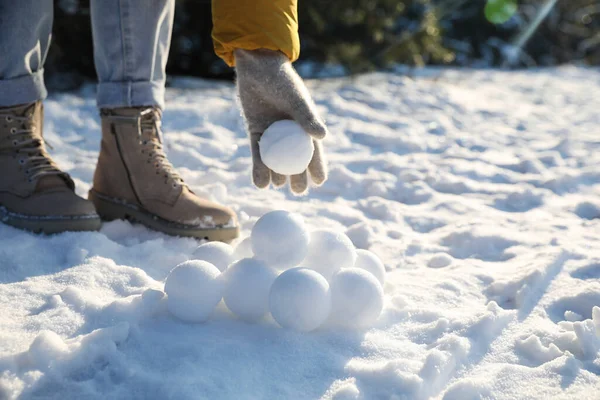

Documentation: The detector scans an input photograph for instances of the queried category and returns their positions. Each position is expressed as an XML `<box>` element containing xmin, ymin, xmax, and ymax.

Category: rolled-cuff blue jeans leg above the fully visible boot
<box><xmin>91</xmin><ymin>0</ymin><xmax>175</xmax><ymax>108</ymax></box>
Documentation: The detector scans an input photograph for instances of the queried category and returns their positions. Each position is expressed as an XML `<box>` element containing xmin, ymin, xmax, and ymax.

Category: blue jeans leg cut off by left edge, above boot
<box><xmin>0</xmin><ymin>0</ymin><xmax>53</xmax><ymax>107</ymax></box>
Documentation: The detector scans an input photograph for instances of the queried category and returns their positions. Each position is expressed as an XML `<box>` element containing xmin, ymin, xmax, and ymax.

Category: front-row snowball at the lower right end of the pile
<box><xmin>330</xmin><ymin>268</ymin><xmax>383</xmax><ymax>328</ymax></box>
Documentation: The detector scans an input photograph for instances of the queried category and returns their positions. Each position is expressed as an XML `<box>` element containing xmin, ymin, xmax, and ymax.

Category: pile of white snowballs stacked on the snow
<box><xmin>165</xmin><ymin>210</ymin><xmax>385</xmax><ymax>332</ymax></box>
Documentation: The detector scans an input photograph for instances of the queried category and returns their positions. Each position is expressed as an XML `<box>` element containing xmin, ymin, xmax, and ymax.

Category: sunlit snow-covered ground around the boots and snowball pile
<box><xmin>0</xmin><ymin>67</ymin><xmax>600</xmax><ymax>400</ymax></box>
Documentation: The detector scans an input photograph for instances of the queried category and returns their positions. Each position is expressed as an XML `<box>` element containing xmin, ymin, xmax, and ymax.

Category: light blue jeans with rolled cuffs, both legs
<box><xmin>0</xmin><ymin>0</ymin><xmax>175</xmax><ymax>108</ymax></box>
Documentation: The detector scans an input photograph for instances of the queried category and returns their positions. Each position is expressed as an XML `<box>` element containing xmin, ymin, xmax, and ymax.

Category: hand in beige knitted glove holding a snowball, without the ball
<box><xmin>234</xmin><ymin>49</ymin><xmax>327</xmax><ymax>194</ymax></box>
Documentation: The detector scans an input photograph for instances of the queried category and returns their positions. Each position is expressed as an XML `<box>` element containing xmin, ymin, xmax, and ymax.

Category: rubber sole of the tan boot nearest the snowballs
<box><xmin>88</xmin><ymin>189</ymin><xmax>240</xmax><ymax>243</ymax></box>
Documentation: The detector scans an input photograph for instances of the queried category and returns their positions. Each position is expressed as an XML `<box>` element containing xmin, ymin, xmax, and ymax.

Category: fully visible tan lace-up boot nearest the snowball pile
<box><xmin>89</xmin><ymin>107</ymin><xmax>239</xmax><ymax>242</ymax></box>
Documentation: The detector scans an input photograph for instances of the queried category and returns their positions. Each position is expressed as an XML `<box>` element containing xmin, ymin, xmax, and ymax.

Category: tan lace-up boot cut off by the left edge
<box><xmin>0</xmin><ymin>102</ymin><xmax>101</xmax><ymax>233</ymax></box>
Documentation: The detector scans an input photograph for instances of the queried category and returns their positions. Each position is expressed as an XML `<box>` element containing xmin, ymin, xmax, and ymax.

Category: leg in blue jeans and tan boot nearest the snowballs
<box><xmin>89</xmin><ymin>0</ymin><xmax>239</xmax><ymax>241</ymax></box>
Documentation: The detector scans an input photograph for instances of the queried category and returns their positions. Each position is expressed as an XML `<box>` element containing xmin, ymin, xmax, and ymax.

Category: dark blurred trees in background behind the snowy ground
<box><xmin>46</xmin><ymin>0</ymin><xmax>600</xmax><ymax>89</ymax></box>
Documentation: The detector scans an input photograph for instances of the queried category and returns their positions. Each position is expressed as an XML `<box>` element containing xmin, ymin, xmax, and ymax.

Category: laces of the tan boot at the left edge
<box><xmin>0</xmin><ymin>112</ymin><xmax>64</xmax><ymax>182</ymax></box>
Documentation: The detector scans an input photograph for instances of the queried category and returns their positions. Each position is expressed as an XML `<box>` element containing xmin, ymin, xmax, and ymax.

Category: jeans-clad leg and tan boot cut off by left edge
<box><xmin>0</xmin><ymin>0</ymin><xmax>100</xmax><ymax>233</ymax></box>
